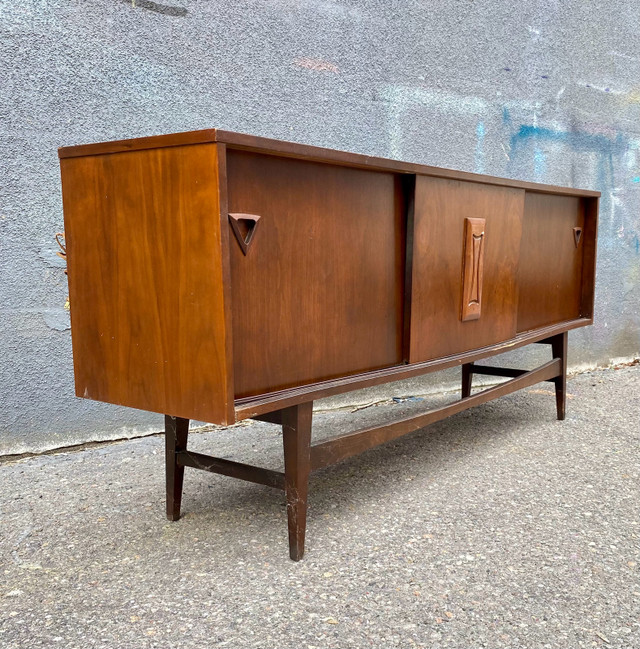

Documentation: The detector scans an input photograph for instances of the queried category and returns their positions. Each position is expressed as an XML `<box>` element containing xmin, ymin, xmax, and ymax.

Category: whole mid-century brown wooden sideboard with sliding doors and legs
<box><xmin>59</xmin><ymin>130</ymin><xmax>599</xmax><ymax>560</ymax></box>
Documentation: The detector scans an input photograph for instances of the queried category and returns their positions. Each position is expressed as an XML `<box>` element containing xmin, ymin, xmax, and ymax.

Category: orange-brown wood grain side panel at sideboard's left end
<box><xmin>61</xmin><ymin>144</ymin><xmax>232</xmax><ymax>423</ymax></box>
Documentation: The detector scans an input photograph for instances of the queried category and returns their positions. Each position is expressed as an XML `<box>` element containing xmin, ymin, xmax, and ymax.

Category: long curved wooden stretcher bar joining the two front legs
<box><xmin>311</xmin><ymin>358</ymin><xmax>562</xmax><ymax>471</ymax></box>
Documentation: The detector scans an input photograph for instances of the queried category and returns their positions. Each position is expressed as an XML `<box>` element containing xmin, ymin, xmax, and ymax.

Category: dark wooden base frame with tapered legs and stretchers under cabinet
<box><xmin>165</xmin><ymin>331</ymin><xmax>567</xmax><ymax>561</ymax></box>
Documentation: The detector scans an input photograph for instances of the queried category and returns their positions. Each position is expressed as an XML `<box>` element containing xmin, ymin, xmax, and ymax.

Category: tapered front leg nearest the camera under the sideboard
<box><xmin>281</xmin><ymin>402</ymin><xmax>313</xmax><ymax>561</ymax></box>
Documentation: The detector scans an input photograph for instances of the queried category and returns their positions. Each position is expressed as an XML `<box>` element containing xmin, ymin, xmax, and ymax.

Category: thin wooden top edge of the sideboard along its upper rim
<box><xmin>58</xmin><ymin>129</ymin><xmax>600</xmax><ymax>197</ymax></box>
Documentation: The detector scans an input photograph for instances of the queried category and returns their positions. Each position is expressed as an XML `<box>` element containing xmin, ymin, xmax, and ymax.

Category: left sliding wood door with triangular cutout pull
<box><xmin>227</xmin><ymin>151</ymin><xmax>404</xmax><ymax>397</ymax></box>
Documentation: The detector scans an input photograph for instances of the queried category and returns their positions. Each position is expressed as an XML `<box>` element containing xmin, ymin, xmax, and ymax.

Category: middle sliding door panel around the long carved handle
<box><xmin>409</xmin><ymin>176</ymin><xmax>524</xmax><ymax>363</ymax></box>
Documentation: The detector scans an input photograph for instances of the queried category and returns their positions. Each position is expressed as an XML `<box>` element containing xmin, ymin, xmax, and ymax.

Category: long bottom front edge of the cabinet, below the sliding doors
<box><xmin>236</xmin><ymin>318</ymin><xmax>593</xmax><ymax>421</ymax></box>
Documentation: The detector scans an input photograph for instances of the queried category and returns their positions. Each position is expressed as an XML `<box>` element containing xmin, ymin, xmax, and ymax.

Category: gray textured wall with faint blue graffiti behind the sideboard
<box><xmin>0</xmin><ymin>0</ymin><xmax>640</xmax><ymax>454</ymax></box>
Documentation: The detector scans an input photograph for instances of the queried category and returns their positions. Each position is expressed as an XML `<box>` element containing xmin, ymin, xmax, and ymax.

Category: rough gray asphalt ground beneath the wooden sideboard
<box><xmin>0</xmin><ymin>365</ymin><xmax>640</xmax><ymax>649</ymax></box>
